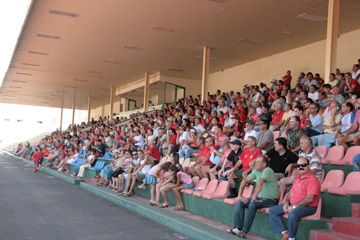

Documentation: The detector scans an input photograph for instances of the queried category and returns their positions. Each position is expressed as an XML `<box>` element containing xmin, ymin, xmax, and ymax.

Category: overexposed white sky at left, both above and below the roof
<box><xmin>0</xmin><ymin>0</ymin><xmax>87</xmax><ymax>147</ymax></box>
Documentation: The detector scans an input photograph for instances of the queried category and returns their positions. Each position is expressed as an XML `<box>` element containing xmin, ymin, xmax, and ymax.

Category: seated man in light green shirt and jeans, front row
<box><xmin>227</xmin><ymin>156</ymin><xmax>279</xmax><ymax>238</ymax></box>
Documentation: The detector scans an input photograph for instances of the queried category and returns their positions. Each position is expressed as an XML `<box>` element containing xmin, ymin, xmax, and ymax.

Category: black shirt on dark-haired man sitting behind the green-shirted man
<box><xmin>266</xmin><ymin>149</ymin><xmax>299</xmax><ymax>173</ymax></box>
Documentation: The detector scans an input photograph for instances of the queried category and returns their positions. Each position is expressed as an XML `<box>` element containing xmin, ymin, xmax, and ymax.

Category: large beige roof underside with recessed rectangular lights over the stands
<box><xmin>0</xmin><ymin>0</ymin><xmax>360</xmax><ymax>109</ymax></box>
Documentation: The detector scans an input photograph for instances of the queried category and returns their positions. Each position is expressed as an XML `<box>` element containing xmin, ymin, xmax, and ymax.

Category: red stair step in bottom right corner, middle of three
<box><xmin>331</xmin><ymin>217</ymin><xmax>360</xmax><ymax>237</ymax></box>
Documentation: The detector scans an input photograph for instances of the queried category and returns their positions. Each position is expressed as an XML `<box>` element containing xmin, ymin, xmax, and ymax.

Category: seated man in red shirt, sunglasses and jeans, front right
<box><xmin>269</xmin><ymin>157</ymin><xmax>320</xmax><ymax>240</ymax></box>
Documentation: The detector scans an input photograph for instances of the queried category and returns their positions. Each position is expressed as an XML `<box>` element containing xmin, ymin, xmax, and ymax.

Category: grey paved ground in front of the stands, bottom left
<box><xmin>0</xmin><ymin>154</ymin><xmax>187</xmax><ymax>240</ymax></box>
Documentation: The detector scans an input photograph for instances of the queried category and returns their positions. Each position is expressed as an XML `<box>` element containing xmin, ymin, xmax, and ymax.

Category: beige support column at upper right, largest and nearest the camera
<box><xmin>324</xmin><ymin>0</ymin><xmax>340</xmax><ymax>81</ymax></box>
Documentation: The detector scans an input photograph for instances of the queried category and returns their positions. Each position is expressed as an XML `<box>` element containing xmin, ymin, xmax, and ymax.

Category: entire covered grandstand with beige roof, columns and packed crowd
<box><xmin>0</xmin><ymin>0</ymin><xmax>360</xmax><ymax>240</ymax></box>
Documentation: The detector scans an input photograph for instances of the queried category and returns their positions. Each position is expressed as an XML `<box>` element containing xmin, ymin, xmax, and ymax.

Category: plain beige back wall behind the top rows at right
<box><xmin>209</xmin><ymin>30</ymin><xmax>360</xmax><ymax>93</ymax></box>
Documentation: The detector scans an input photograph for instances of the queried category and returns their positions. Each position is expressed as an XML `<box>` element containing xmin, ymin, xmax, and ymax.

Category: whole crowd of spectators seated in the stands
<box><xmin>16</xmin><ymin>59</ymin><xmax>360</xmax><ymax>239</ymax></box>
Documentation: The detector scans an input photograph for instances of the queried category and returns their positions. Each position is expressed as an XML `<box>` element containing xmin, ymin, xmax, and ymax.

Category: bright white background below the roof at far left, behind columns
<box><xmin>0</xmin><ymin>103</ymin><xmax>87</xmax><ymax>147</ymax></box>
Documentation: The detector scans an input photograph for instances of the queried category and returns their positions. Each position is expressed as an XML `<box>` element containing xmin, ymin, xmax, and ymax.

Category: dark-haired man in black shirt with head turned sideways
<box><xmin>266</xmin><ymin>137</ymin><xmax>299</xmax><ymax>179</ymax></box>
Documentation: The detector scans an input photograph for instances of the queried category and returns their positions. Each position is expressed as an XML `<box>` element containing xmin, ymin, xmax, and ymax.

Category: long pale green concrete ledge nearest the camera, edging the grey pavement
<box><xmin>80</xmin><ymin>182</ymin><xmax>240</xmax><ymax>240</ymax></box>
